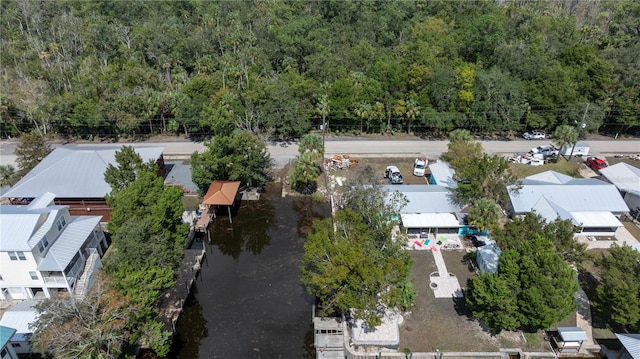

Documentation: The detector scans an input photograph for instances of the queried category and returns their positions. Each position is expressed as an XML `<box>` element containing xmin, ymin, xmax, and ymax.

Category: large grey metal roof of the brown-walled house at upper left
<box><xmin>2</xmin><ymin>146</ymin><xmax>163</xmax><ymax>198</ymax></box>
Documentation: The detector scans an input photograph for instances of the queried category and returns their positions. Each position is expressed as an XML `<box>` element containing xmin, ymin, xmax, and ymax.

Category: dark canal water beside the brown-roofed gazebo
<box><xmin>169</xmin><ymin>183</ymin><xmax>330</xmax><ymax>359</ymax></box>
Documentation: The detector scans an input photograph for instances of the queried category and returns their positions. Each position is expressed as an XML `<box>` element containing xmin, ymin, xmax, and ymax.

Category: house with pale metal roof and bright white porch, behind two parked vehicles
<box><xmin>383</xmin><ymin>185</ymin><xmax>463</xmax><ymax>236</ymax></box>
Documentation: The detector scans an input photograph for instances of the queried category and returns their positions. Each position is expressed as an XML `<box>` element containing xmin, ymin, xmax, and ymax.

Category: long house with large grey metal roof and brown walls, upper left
<box><xmin>2</xmin><ymin>146</ymin><xmax>165</xmax><ymax>222</ymax></box>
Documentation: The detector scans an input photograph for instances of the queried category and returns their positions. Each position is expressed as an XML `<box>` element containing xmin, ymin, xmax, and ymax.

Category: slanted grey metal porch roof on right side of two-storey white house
<box><xmin>38</xmin><ymin>216</ymin><xmax>102</xmax><ymax>271</ymax></box>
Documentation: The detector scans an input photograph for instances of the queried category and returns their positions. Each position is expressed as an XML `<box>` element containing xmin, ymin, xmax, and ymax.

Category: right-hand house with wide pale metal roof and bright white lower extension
<box><xmin>508</xmin><ymin>171</ymin><xmax>629</xmax><ymax>236</ymax></box>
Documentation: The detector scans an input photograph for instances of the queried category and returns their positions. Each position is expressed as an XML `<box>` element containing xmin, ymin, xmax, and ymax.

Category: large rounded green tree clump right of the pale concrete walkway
<box><xmin>465</xmin><ymin>234</ymin><xmax>578</xmax><ymax>332</ymax></box>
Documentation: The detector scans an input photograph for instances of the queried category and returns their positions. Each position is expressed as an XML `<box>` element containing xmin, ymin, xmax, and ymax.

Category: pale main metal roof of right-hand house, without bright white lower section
<box><xmin>509</xmin><ymin>171</ymin><xmax>629</xmax><ymax>213</ymax></box>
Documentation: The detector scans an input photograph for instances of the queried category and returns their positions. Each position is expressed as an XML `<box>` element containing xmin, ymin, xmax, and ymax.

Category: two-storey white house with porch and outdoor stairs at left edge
<box><xmin>0</xmin><ymin>192</ymin><xmax>108</xmax><ymax>300</ymax></box>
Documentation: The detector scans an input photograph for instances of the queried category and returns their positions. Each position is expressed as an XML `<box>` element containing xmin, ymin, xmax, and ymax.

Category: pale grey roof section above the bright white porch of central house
<box><xmin>382</xmin><ymin>185</ymin><xmax>461</xmax><ymax>213</ymax></box>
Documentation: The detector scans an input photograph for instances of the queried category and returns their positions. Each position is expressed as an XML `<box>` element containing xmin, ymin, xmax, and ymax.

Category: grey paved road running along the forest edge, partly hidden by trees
<box><xmin>0</xmin><ymin>138</ymin><xmax>640</xmax><ymax>166</ymax></box>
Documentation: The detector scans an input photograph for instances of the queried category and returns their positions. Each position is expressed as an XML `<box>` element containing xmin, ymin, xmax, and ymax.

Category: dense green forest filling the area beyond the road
<box><xmin>0</xmin><ymin>0</ymin><xmax>640</xmax><ymax>139</ymax></box>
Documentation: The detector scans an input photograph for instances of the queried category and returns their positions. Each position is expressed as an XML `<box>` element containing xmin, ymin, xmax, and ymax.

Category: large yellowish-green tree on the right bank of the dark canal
<box><xmin>302</xmin><ymin>188</ymin><xmax>415</xmax><ymax>327</ymax></box>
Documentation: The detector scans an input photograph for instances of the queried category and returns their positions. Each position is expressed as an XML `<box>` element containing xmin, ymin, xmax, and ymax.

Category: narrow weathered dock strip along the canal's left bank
<box><xmin>159</xmin><ymin>249</ymin><xmax>206</xmax><ymax>333</ymax></box>
